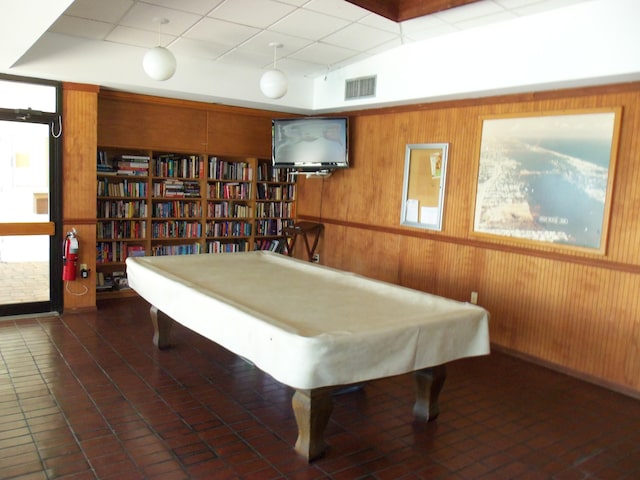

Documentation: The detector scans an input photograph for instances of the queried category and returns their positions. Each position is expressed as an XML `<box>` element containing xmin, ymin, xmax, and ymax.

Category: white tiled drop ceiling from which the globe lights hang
<box><xmin>43</xmin><ymin>0</ymin><xmax>580</xmax><ymax>80</ymax></box>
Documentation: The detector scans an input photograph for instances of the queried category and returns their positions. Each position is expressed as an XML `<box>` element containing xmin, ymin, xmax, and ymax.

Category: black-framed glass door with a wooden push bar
<box><xmin>0</xmin><ymin>77</ymin><xmax>62</xmax><ymax>316</ymax></box>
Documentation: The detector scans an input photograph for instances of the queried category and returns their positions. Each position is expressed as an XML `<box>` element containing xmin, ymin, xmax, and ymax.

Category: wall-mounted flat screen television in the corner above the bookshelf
<box><xmin>271</xmin><ymin>117</ymin><xmax>349</xmax><ymax>172</ymax></box>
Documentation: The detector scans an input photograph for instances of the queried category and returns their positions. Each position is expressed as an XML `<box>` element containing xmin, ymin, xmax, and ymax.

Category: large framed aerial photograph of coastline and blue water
<box><xmin>473</xmin><ymin>108</ymin><xmax>621</xmax><ymax>254</ymax></box>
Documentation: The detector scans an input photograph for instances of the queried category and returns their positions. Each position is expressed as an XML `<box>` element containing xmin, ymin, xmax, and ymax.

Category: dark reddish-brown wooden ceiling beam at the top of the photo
<box><xmin>347</xmin><ymin>0</ymin><xmax>479</xmax><ymax>22</ymax></box>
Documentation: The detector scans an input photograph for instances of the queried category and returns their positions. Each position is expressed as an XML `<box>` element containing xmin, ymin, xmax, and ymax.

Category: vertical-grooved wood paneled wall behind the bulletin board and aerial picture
<box><xmin>297</xmin><ymin>83</ymin><xmax>640</xmax><ymax>396</ymax></box>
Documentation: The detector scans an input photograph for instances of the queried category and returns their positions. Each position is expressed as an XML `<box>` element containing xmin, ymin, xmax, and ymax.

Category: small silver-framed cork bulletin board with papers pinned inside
<box><xmin>400</xmin><ymin>143</ymin><xmax>449</xmax><ymax>230</ymax></box>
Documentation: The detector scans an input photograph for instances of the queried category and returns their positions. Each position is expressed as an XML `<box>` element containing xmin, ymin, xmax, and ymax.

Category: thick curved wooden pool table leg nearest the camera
<box><xmin>291</xmin><ymin>387</ymin><xmax>335</xmax><ymax>462</ymax></box>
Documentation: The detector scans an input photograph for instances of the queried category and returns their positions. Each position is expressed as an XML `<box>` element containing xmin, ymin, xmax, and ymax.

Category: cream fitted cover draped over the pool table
<box><xmin>126</xmin><ymin>252</ymin><xmax>489</xmax><ymax>389</ymax></box>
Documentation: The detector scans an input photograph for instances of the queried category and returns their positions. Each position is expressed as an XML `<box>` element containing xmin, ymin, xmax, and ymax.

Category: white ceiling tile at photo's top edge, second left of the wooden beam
<box><xmin>209</xmin><ymin>0</ymin><xmax>296</xmax><ymax>28</ymax></box>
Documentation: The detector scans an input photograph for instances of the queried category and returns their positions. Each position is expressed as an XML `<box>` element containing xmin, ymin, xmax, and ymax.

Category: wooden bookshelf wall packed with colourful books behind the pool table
<box><xmin>96</xmin><ymin>148</ymin><xmax>296</xmax><ymax>298</ymax></box>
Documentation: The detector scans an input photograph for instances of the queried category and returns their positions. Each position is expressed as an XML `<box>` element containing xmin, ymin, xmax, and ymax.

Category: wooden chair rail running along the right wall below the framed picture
<box><xmin>298</xmin><ymin>215</ymin><xmax>640</xmax><ymax>274</ymax></box>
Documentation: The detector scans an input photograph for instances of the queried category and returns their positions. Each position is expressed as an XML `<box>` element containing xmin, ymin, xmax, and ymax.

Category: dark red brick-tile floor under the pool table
<box><xmin>0</xmin><ymin>299</ymin><xmax>640</xmax><ymax>480</ymax></box>
